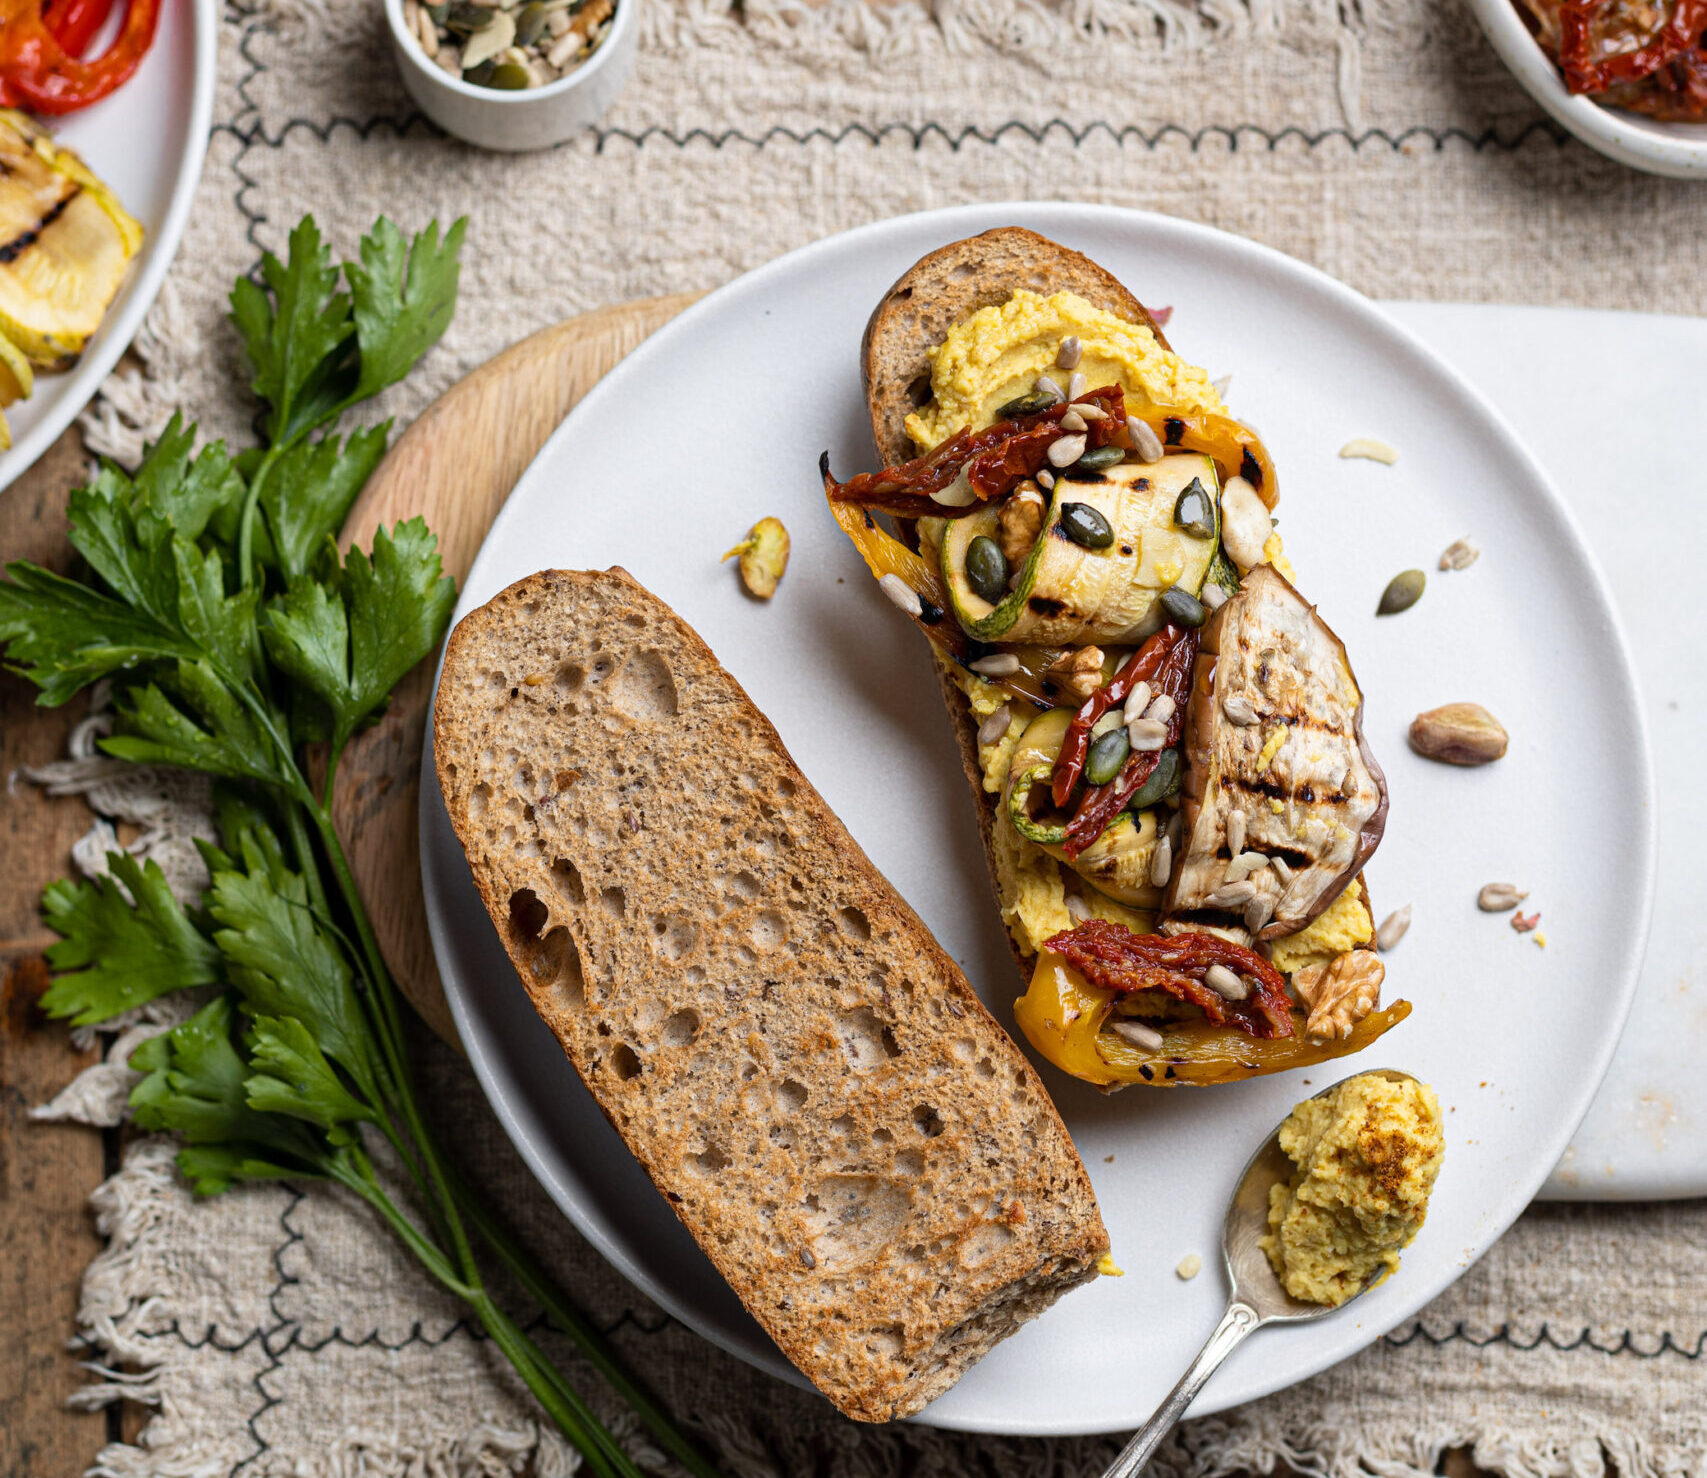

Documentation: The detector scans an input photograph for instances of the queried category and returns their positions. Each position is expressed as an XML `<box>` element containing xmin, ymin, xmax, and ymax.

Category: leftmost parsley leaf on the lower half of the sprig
<box><xmin>41</xmin><ymin>852</ymin><xmax>220</xmax><ymax>1026</ymax></box>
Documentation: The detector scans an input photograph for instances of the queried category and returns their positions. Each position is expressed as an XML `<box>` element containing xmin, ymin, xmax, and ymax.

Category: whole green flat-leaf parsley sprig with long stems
<box><xmin>0</xmin><ymin>217</ymin><xmax>715</xmax><ymax>1478</ymax></box>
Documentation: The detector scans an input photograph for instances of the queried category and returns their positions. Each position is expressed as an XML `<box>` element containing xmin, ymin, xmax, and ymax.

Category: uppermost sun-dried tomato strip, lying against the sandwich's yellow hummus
<box><xmin>828</xmin><ymin>386</ymin><xmax>1127</xmax><ymax>519</ymax></box>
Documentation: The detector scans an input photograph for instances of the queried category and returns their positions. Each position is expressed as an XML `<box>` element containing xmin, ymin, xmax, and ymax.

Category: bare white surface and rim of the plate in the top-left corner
<box><xmin>0</xmin><ymin>0</ymin><xmax>218</xmax><ymax>488</ymax></box>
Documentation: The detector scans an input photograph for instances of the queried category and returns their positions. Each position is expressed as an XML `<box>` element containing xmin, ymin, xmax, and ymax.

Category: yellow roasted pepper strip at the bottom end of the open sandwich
<box><xmin>1014</xmin><ymin>949</ymin><xmax>1410</xmax><ymax>1089</ymax></box>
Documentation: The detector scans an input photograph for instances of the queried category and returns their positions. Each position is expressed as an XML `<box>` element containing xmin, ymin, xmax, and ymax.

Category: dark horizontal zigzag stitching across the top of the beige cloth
<box><xmin>215</xmin><ymin>113</ymin><xmax>1570</xmax><ymax>157</ymax></box>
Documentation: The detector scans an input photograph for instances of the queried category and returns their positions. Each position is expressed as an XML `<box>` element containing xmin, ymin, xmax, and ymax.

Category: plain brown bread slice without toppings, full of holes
<box><xmin>434</xmin><ymin>570</ymin><xmax>1108</xmax><ymax>1422</ymax></box>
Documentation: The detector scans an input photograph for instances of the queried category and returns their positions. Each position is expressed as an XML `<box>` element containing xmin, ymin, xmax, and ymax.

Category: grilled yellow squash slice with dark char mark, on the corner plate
<box><xmin>0</xmin><ymin>111</ymin><xmax>142</xmax><ymax>369</ymax></box>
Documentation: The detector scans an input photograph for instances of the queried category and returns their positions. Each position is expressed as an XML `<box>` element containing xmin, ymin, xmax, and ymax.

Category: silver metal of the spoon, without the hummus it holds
<box><xmin>1103</xmin><ymin>1067</ymin><xmax>1415</xmax><ymax>1478</ymax></box>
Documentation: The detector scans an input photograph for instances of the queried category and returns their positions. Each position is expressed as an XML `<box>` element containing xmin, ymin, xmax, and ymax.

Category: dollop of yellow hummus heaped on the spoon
<box><xmin>1261</xmin><ymin>1074</ymin><xmax>1446</xmax><ymax>1307</ymax></box>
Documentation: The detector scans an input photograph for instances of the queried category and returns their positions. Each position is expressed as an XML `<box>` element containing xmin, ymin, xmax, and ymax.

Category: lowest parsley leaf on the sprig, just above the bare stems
<box><xmin>130</xmin><ymin>995</ymin><xmax>328</xmax><ymax>1196</ymax></box>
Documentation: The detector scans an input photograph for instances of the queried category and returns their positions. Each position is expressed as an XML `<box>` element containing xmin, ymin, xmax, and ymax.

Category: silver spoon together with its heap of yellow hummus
<box><xmin>1103</xmin><ymin>1068</ymin><xmax>1444</xmax><ymax>1478</ymax></box>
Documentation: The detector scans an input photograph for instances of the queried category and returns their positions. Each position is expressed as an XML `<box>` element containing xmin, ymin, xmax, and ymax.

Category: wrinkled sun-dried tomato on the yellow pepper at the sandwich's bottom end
<box><xmin>1045</xmin><ymin>918</ymin><xmax>1294</xmax><ymax>1038</ymax></box>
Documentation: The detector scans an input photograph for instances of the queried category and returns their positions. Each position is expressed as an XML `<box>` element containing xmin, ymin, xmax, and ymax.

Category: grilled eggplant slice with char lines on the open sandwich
<box><xmin>1164</xmin><ymin>565</ymin><xmax>1388</xmax><ymax>939</ymax></box>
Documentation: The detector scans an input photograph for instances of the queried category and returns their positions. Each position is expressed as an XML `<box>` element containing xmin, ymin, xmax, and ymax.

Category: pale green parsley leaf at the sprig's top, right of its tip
<box><xmin>343</xmin><ymin>217</ymin><xmax>468</xmax><ymax>399</ymax></box>
